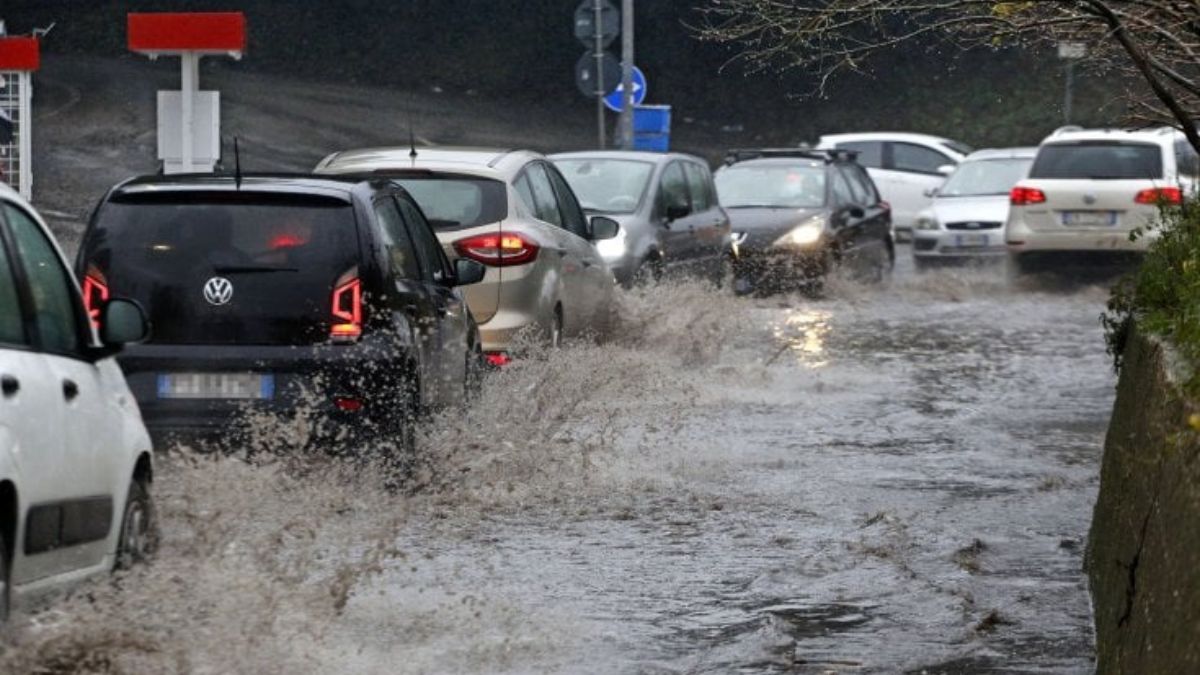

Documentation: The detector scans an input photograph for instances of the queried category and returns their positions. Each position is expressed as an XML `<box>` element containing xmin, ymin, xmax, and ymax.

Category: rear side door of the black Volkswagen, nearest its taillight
<box><xmin>373</xmin><ymin>196</ymin><xmax>443</xmax><ymax>406</ymax></box>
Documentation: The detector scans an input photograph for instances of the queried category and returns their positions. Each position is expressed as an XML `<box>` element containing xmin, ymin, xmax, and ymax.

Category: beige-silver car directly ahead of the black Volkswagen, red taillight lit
<box><xmin>314</xmin><ymin>148</ymin><xmax>618</xmax><ymax>365</ymax></box>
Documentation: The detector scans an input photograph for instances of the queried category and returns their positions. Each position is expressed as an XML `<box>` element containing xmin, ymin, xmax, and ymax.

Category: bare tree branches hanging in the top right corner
<box><xmin>698</xmin><ymin>0</ymin><xmax>1200</xmax><ymax>151</ymax></box>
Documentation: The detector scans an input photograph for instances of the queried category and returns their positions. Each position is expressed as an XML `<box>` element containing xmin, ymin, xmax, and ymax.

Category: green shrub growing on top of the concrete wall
<box><xmin>1102</xmin><ymin>197</ymin><xmax>1200</xmax><ymax>394</ymax></box>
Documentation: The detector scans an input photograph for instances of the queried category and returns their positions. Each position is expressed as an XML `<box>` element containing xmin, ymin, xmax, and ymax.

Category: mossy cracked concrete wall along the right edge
<box><xmin>1086</xmin><ymin>334</ymin><xmax>1200</xmax><ymax>674</ymax></box>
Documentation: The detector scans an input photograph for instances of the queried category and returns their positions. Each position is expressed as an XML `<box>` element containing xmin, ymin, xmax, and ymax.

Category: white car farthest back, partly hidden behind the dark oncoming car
<box><xmin>817</xmin><ymin>132</ymin><xmax>971</xmax><ymax>233</ymax></box>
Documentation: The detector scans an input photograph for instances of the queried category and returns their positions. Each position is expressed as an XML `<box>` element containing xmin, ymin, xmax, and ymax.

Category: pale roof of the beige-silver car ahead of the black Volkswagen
<box><xmin>316</xmin><ymin>145</ymin><xmax>541</xmax><ymax>178</ymax></box>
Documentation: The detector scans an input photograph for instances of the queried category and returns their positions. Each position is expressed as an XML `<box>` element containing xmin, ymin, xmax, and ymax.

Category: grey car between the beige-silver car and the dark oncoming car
<box><xmin>550</xmin><ymin>150</ymin><xmax>732</xmax><ymax>286</ymax></box>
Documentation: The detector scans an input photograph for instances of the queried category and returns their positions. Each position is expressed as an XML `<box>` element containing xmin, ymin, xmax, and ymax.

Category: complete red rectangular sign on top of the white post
<box><xmin>128</xmin><ymin>12</ymin><xmax>246</xmax><ymax>54</ymax></box>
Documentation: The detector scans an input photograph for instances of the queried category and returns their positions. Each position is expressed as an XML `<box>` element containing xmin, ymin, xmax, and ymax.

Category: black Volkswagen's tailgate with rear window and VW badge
<box><xmin>79</xmin><ymin>193</ymin><xmax>360</xmax><ymax>345</ymax></box>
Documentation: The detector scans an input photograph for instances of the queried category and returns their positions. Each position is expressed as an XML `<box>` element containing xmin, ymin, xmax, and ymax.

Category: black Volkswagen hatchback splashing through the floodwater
<box><xmin>77</xmin><ymin>175</ymin><xmax>484</xmax><ymax>447</ymax></box>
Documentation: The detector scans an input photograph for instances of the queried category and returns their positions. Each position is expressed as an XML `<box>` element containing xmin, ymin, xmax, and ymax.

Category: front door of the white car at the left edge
<box><xmin>0</xmin><ymin>198</ymin><xmax>118</xmax><ymax>584</ymax></box>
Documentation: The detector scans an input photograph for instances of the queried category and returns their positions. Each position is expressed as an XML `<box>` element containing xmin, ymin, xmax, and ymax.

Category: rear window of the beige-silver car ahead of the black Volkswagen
<box><xmin>395</xmin><ymin>175</ymin><xmax>509</xmax><ymax>229</ymax></box>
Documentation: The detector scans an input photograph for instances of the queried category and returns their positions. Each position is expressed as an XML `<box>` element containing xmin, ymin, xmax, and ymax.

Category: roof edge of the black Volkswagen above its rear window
<box><xmin>113</xmin><ymin>173</ymin><xmax>368</xmax><ymax>201</ymax></box>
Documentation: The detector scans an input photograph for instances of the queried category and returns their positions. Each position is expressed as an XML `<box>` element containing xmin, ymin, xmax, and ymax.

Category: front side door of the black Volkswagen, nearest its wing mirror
<box><xmin>396</xmin><ymin>195</ymin><xmax>470</xmax><ymax>405</ymax></box>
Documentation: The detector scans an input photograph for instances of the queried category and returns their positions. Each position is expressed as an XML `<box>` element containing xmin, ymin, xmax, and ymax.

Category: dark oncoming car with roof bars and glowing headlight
<box><xmin>716</xmin><ymin>149</ymin><xmax>895</xmax><ymax>292</ymax></box>
